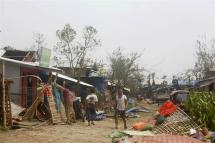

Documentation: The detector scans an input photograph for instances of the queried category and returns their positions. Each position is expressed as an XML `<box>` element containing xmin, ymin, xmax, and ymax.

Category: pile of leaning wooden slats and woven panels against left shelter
<box><xmin>12</xmin><ymin>85</ymin><xmax>77</xmax><ymax>128</ymax></box>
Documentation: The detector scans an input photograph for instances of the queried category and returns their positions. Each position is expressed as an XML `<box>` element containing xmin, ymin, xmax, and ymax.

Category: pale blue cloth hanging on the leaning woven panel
<box><xmin>52</xmin><ymin>84</ymin><xmax>61</xmax><ymax>112</ymax></box>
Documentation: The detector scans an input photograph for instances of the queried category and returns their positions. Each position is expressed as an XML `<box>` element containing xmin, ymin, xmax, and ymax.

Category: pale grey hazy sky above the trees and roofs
<box><xmin>0</xmin><ymin>0</ymin><xmax>215</xmax><ymax>76</ymax></box>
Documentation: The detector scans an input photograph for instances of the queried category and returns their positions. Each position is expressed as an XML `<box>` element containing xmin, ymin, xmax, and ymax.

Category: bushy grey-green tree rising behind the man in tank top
<box><xmin>109</xmin><ymin>48</ymin><xmax>143</xmax><ymax>93</ymax></box>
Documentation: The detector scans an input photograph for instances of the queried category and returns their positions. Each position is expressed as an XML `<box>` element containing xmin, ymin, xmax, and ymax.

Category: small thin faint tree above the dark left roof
<box><xmin>32</xmin><ymin>33</ymin><xmax>46</xmax><ymax>60</ymax></box>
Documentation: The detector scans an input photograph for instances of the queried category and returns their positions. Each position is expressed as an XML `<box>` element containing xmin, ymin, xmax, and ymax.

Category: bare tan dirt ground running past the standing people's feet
<box><xmin>0</xmin><ymin>101</ymin><xmax>156</xmax><ymax>143</ymax></box>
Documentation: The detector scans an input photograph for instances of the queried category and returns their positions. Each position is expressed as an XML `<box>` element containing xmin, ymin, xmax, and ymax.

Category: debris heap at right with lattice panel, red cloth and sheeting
<box><xmin>110</xmin><ymin>101</ymin><xmax>215</xmax><ymax>143</ymax></box>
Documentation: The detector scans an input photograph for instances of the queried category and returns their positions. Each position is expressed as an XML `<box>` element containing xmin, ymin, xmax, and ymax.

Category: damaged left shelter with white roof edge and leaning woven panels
<box><xmin>0</xmin><ymin>57</ymin><xmax>93</xmax><ymax>127</ymax></box>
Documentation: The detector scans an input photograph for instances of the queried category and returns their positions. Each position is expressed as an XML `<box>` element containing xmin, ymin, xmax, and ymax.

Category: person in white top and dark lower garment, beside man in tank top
<box><xmin>86</xmin><ymin>88</ymin><xmax>98</xmax><ymax>126</ymax></box>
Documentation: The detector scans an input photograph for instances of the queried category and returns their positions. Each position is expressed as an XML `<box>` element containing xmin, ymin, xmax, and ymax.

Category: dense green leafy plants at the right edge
<box><xmin>184</xmin><ymin>92</ymin><xmax>215</xmax><ymax>130</ymax></box>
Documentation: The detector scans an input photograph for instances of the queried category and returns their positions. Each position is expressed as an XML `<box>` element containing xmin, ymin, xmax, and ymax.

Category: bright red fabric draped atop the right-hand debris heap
<box><xmin>159</xmin><ymin>101</ymin><xmax>176</xmax><ymax>116</ymax></box>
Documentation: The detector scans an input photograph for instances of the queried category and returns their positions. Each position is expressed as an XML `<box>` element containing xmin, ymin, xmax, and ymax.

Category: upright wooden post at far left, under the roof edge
<box><xmin>2</xmin><ymin>61</ymin><xmax>6</xmax><ymax>128</ymax></box>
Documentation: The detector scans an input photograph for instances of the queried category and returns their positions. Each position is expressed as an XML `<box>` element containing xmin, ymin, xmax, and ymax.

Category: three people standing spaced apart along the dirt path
<box><xmin>57</xmin><ymin>82</ymin><xmax>128</xmax><ymax>129</ymax></box>
